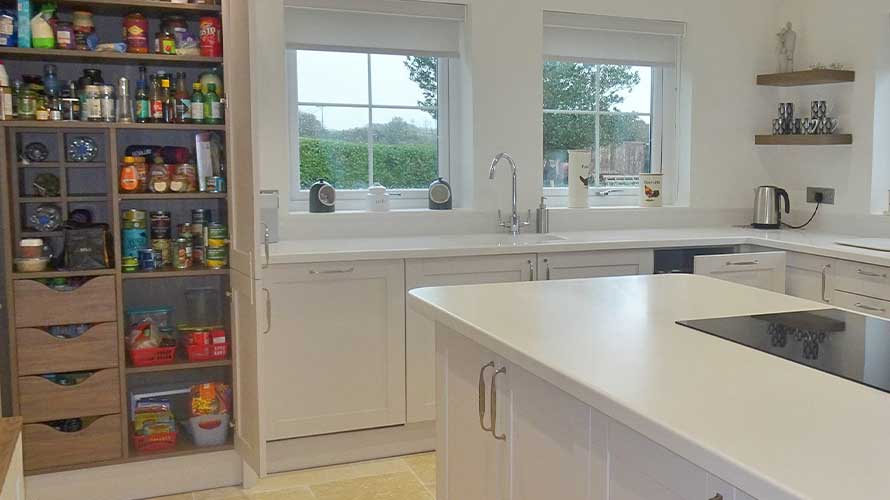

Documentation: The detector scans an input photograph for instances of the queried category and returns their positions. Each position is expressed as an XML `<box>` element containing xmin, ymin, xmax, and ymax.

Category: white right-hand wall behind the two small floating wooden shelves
<box><xmin>759</xmin><ymin>0</ymin><xmax>890</xmax><ymax>230</ymax></box>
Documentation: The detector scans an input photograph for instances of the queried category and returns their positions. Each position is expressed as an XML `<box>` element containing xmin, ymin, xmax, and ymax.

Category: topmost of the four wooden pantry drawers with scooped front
<box><xmin>13</xmin><ymin>276</ymin><xmax>117</xmax><ymax>328</ymax></box>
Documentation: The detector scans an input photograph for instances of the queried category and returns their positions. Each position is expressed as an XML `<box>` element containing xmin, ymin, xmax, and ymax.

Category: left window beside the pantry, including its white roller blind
<box><xmin>284</xmin><ymin>0</ymin><xmax>466</xmax><ymax>211</ymax></box>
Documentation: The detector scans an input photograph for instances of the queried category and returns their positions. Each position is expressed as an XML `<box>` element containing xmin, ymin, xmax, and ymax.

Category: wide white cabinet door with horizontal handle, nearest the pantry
<box><xmin>261</xmin><ymin>260</ymin><xmax>405</xmax><ymax>440</ymax></box>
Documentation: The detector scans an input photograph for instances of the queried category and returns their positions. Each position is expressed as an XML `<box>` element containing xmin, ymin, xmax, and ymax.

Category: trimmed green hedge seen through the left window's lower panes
<box><xmin>300</xmin><ymin>138</ymin><xmax>439</xmax><ymax>189</ymax></box>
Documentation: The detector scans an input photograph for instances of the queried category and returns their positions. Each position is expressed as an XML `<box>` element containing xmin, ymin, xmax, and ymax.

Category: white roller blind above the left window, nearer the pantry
<box><xmin>285</xmin><ymin>0</ymin><xmax>466</xmax><ymax>57</ymax></box>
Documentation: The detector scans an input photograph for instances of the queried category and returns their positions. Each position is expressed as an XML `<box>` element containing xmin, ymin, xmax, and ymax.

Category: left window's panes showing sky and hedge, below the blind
<box><xmin>292</xmin><ymin>50</ymin><xmax>448</xmax><ymax>196</ymax></box>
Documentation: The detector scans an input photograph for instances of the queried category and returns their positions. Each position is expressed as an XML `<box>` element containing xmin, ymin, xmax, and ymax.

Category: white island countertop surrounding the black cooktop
<box><xmin>409</xmin><ymin>276</ymin><xmax>890</xmax><ymax>500</ymax></box>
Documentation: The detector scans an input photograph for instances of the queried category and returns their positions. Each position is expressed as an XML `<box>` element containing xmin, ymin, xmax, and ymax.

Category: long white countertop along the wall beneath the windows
<box><xmin>266</xmin><ymin>226</ymin><xmax>890</xmax><ymax>266</ymax></box>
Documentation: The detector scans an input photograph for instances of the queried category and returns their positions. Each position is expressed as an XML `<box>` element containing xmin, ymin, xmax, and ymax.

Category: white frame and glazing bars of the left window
<box><xmin>286</xmin><ymin>46</ymin><xmax>456</xmax><ymax>212</ymax></box>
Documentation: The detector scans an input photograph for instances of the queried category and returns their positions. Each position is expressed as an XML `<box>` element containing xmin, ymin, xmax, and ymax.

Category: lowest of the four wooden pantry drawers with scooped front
<box><xmin>23</xmin><ymin>414</ymin><xmax>122</xmax><ymax>471</ymax></box>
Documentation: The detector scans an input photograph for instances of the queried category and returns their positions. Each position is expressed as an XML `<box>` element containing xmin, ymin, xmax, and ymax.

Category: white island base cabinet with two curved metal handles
<box><xmin>436</xmin><ymin>325</ymin><xmax>754</xmax><ymax>500</ymax></box>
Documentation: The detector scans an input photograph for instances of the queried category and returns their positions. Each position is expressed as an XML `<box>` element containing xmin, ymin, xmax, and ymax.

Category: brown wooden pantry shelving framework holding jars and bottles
<box><xmin>0</xmin><ymin>0</ymin><xmax>243</xmax><ymax>476</ymax></box>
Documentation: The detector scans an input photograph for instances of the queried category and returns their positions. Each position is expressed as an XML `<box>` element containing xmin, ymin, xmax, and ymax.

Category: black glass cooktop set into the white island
<box><xmin>677</xmin><ymin>309</ymin><xmax>890</xmax><ymax>393</ymax></box>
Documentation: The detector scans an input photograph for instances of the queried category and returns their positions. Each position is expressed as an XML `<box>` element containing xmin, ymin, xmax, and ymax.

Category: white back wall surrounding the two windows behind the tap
<box><xmin>253</xmin><ymin>0</ymin><xmax>780</xmax><ymax>238</ymax></box>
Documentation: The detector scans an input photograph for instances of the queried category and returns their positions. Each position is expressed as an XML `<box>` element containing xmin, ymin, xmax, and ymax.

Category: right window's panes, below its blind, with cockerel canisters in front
<box><xmin>544</xmin><ymin>60</ymin><xmax>661</xmax><ymax>195</ymax></box>
